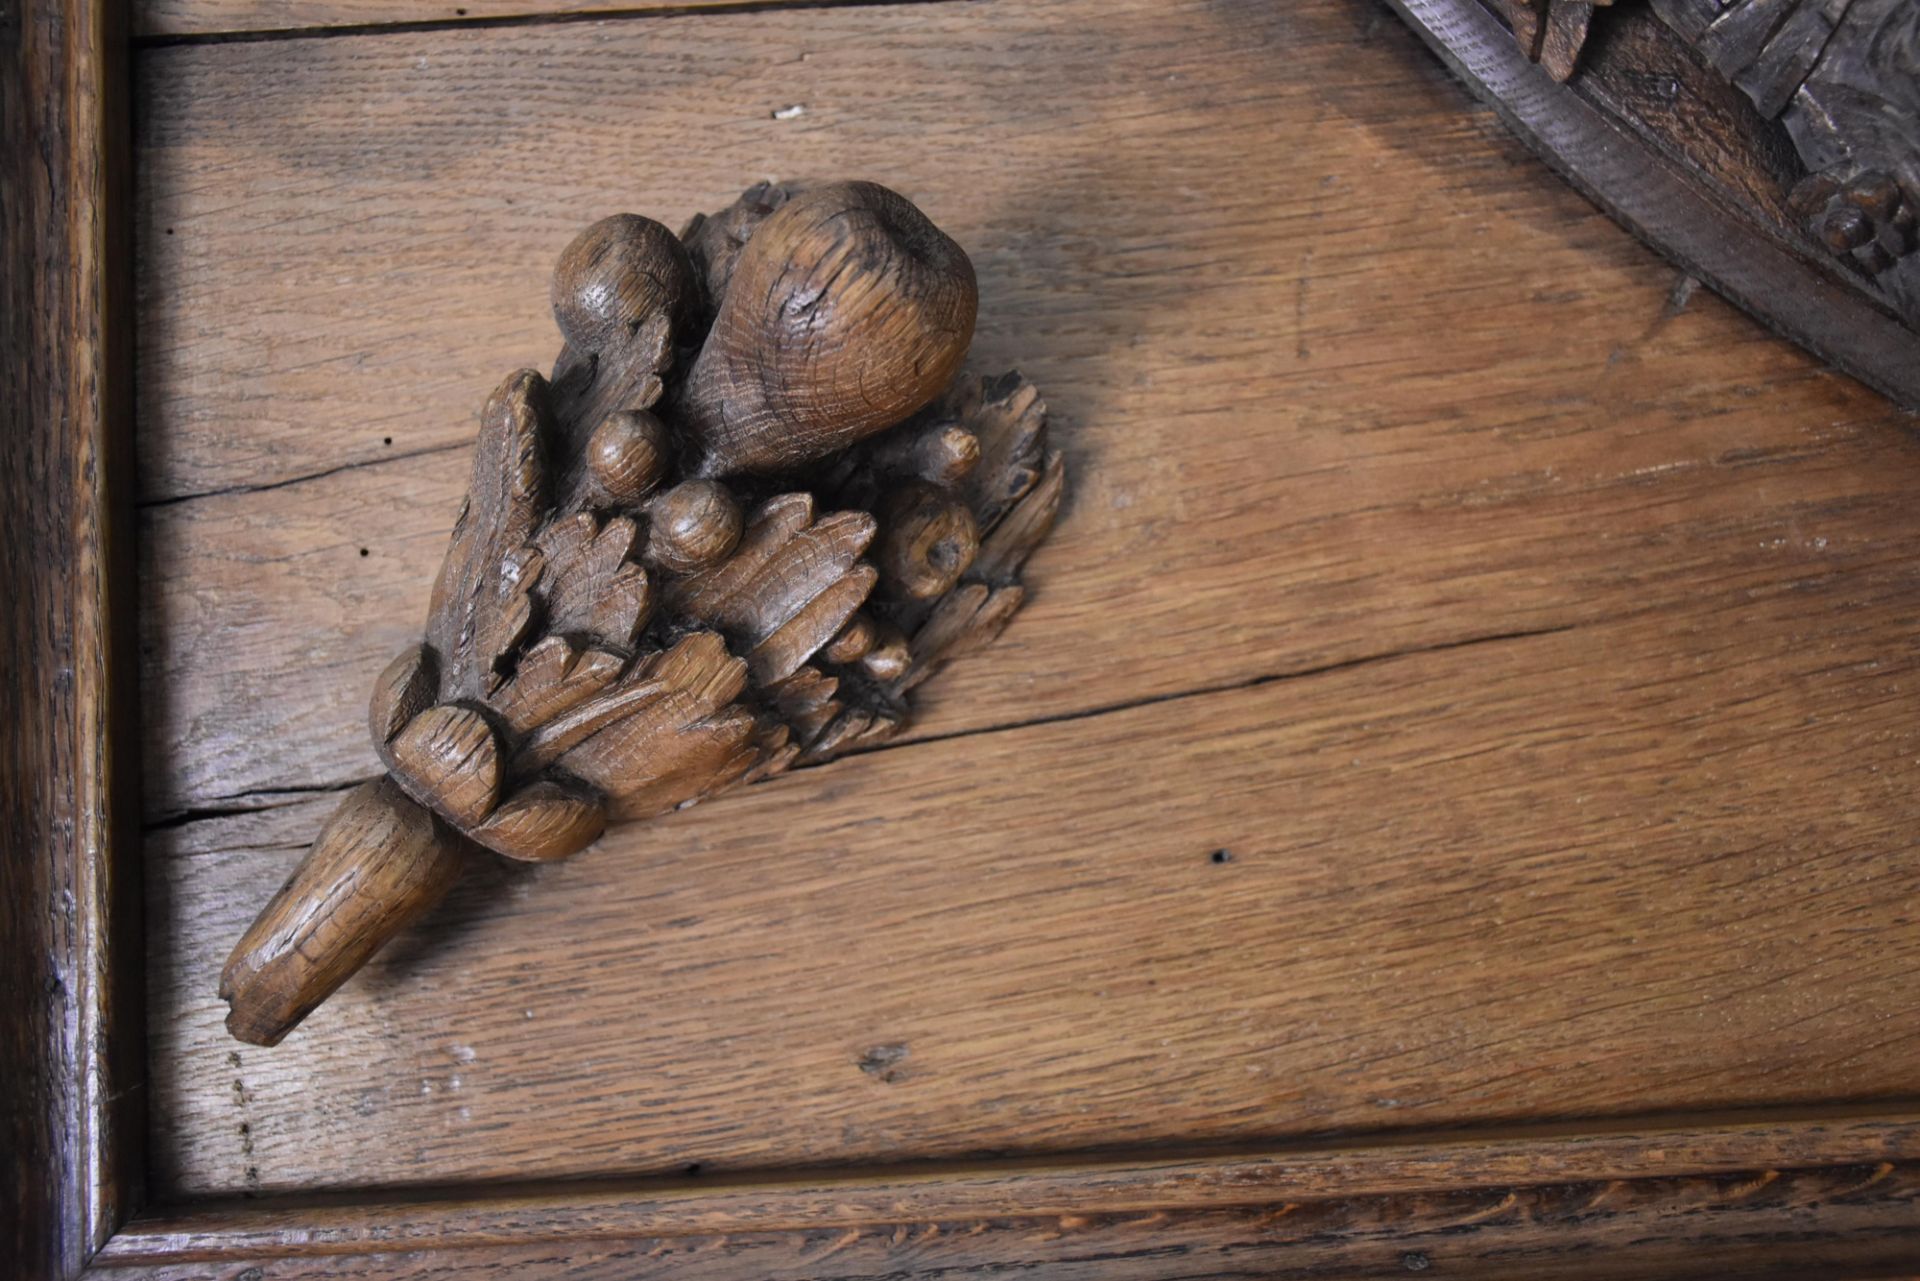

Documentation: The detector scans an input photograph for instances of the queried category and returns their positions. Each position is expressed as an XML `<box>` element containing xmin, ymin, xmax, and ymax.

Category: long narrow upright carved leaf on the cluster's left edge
<box><xmin>426</xmin><ymin>369</ymin><xmax>549</xmax><ymax>699</ymax></box>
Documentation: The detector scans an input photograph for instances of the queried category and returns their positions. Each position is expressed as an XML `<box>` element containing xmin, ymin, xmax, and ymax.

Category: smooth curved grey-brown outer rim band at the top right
<box><xmin>1388</xmin><ymin>0</ymin><xmax>1920</xmax><ymax>407</ymax></box>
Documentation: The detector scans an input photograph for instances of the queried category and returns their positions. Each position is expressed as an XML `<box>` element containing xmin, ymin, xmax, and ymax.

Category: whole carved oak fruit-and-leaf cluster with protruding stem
<box><xmin>221</xmin><ymin>182</ymin><xmax>1064</xmax><ymax>1045</ymax></box>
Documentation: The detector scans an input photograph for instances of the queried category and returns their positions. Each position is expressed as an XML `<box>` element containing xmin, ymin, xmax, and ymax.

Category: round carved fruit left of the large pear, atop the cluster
<box><xmin>553</xmin><ymin>213</ymin><xmax>699</xmax><ymax>351</ymax></box>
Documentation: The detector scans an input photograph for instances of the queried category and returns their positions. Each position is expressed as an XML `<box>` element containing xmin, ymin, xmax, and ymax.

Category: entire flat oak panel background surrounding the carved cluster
<box><xmin>142</xmin><ymin>0</ymin><xmax>1920</xmax><ymax>1229</ymax></box>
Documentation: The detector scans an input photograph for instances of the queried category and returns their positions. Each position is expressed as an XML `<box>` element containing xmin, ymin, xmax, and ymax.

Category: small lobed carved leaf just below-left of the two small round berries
<box><xmin>536</xmin><ymin>511</ymin><xmax>653</xmax><ymax>649</ymax></box>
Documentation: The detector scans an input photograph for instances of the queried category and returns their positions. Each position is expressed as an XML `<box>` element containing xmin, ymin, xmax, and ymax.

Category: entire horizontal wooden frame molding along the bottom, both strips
<box><xmin>98</xmin><ymin>1116</ymin><xmax>1920</xmax><ymax>1279</ymax></box>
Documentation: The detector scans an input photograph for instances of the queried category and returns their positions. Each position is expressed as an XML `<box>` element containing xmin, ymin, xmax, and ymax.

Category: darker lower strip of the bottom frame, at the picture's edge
<box><xmin>88</xmin><ymin>1162</ymin><xmax>1920</xmax><ymax>1281</ymax></box>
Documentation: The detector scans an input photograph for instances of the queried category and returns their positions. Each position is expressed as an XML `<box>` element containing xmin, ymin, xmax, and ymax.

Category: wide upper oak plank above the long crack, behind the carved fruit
<box><xmin>142</xmin><ymin>0</ymin><xmax>1920</xmax><ymax>816</ymax></box>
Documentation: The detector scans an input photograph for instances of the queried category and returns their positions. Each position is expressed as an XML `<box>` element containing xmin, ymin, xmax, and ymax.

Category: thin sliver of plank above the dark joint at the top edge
<box><xmin>132</xmin><ymin>0</ymin><xmax>925</xmax><ymax>40</ymax></box>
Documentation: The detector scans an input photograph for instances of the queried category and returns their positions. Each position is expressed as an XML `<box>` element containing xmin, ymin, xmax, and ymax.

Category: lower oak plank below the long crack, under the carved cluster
<box><xmin>148</xmin><ymin>587</ymin><xmax>1920</xmax><ymax>1196</ymax></box>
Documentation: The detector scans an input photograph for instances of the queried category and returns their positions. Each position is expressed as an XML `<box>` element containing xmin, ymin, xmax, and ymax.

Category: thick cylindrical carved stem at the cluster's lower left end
<box><xmin>221</xmin><ymin>778</ymin><xmax>467</xmax><ymax>1045</ymax></box>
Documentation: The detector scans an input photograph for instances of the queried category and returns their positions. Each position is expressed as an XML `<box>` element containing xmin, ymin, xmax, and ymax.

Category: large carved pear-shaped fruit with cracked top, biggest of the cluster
<box><xmin>682</xmin><ymin>182</ymin><xmax>979</xmax><ymax>476</ymax></box>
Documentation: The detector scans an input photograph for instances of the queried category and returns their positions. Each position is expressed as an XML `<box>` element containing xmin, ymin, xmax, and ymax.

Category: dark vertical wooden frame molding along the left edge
<box><xmin>0</xmin><ymin>0</ymin><xmax>146</xmax><ymax>1277</ymax></box>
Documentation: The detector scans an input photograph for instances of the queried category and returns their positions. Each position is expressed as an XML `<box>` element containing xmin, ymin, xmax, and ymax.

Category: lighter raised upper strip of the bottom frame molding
<box><xmin>100</xmin><ymin>1108</ymin><xmax>1920</xmax><ymax>1268</ymax></box>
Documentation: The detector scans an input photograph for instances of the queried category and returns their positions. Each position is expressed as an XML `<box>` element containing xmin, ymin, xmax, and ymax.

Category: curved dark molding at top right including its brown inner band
<box><xmin>1390</xmin><ymin>0</ymin><xmax>1920</xmax><ymax>407</ymax></box>
